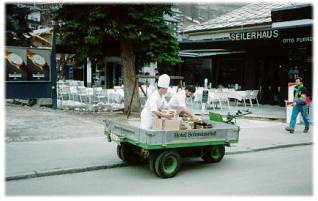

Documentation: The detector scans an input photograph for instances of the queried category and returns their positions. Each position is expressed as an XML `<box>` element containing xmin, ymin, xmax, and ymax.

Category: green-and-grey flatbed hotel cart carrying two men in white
<box><xmin>104</xmin><ymin>110</ymin><xmax>251</xmax><ymax>178</ymax></box>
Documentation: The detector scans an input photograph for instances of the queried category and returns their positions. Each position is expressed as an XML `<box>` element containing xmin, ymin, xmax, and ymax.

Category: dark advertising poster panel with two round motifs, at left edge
<box><xmin>5</xmin><ymin>47</ymin><xmax>51</xmax><ymax>82</ymax></box>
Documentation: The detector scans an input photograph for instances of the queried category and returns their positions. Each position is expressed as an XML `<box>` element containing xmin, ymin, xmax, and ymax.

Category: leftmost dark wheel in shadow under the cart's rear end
<box><xmin>117</xmin><ymin>143</ymin><xmax>140</xmax><ymax>165</ymax></box>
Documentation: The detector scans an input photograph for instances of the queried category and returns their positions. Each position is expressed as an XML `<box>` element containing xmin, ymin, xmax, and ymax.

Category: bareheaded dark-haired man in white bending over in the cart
<box><xmin>168</xmin><ymin>86</ymin><xmax>199</xmax><ymax>121</ymax></box>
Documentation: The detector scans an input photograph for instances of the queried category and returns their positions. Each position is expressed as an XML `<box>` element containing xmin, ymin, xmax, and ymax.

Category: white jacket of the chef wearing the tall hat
<box><xmin>140</xmin><ymin>90</ymin><xmax>168</xmax><ymax>129</ymax></box>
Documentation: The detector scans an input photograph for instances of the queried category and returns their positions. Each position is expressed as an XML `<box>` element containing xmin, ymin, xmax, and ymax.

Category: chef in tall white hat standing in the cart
<box><xmin>140</xmin><ymin>74</ymin><xmax>173</xmax><ymax>129</ymax></box>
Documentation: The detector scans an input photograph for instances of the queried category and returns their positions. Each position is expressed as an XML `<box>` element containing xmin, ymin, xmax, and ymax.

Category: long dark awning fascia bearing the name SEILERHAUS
<box><xmin>179</xmin><ymin>24</ymin><xmax>313</xmax><ymax>51</ymax></box>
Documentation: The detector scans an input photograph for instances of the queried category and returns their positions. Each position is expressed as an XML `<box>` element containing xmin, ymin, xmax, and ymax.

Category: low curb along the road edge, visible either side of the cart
<box><xmin>5</xmin><ymin>142</ymin><xmax>313</xmax><ymax>181</ymax></box>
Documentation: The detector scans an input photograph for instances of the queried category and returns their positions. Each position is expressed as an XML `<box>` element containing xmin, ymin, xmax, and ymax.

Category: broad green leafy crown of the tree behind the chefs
<box><xmin>56</xmin><ymin>4</ymin><xmax>180</xmax><ymax>67</ymax></box>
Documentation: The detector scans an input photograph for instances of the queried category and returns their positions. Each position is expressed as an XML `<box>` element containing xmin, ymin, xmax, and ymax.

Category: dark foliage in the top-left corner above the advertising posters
<box><xmin>5</xmin><ymin>4</ymin><xmax>31</xmax><ymax>47</ymax></box>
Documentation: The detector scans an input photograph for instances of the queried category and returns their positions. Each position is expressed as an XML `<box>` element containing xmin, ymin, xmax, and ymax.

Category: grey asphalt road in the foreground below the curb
<box><xmin>5</xmin><ymin>146</ymin><xmax>313</xmax><ymax>196</ymax></box>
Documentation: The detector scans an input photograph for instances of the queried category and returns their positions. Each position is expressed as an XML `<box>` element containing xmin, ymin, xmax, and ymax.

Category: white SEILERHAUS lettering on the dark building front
<box><xmin>230</xmin><ymin>29</ymin><xmax>279</xmax><ymax>41</ymax></box>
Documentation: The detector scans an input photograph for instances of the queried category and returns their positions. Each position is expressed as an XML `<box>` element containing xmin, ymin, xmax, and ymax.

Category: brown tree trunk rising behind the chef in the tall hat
<box><xmin>120</xmin><ymin>42</ymin><xmax>140</xmax><ymax>114</ymax></box>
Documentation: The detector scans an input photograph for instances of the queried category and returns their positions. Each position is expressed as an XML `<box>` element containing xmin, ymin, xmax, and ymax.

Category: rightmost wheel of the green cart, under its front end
<box><xmin>201</xmin><ymin>145</ymin><xmax>225</xmax><ymax>163</ymax></box>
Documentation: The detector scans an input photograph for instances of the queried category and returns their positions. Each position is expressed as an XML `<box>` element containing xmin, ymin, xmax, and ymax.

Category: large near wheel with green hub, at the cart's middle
<box><xmin>155</xmin><ymin>150</ymin><xmax>181</xmax><ymax>178</ymax></box>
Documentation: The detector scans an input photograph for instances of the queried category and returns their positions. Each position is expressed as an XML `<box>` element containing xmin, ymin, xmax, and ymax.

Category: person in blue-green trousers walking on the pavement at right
<box><xmin>286</xmin><ymin>77</ymin><xmax>310</xmax><ymax>133</ymax></box>
